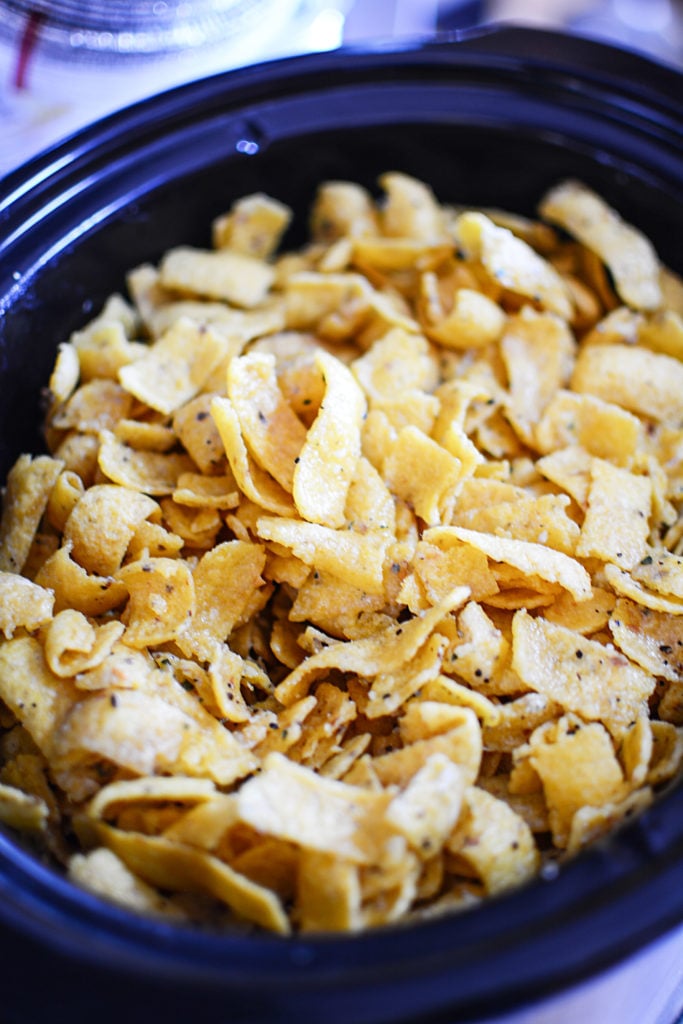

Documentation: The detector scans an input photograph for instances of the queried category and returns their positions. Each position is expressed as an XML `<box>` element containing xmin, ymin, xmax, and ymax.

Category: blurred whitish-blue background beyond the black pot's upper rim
<box><xmin>0</xmin><ymin>0</ymin><xmax>683</xmax><ymax>175</ymax></box>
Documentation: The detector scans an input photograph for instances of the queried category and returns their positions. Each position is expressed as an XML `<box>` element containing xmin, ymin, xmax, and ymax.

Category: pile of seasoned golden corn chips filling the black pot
<box><xmin>0</xmin><ymin>172</ymin><xmax>683</xmax><ymax>934</ymax></box>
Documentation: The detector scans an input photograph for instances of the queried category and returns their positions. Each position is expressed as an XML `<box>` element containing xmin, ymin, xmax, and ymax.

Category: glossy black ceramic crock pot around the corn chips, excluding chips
<box><xmin>0</xmin><ymin>24</ymin><xmax>683</xmax><ymax>1024</ymax></box>
